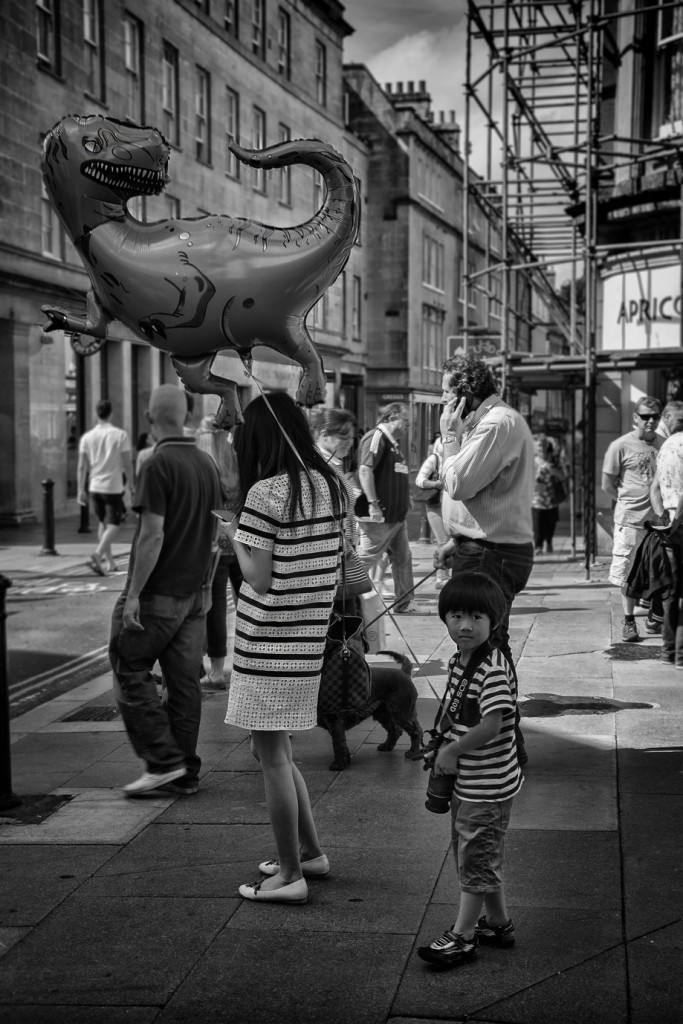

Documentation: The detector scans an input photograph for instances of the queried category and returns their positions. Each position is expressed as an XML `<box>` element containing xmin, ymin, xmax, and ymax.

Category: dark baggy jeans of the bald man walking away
<box><xmin>110</xmin><ymin>588</ymin><xmax>210</xmax><ymax>779</ymax></box>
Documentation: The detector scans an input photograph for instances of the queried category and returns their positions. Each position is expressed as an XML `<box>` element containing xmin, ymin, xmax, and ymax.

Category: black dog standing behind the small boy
<box><xmin>317</xmin><ymin>650</ymin><xmax>423</xmax><ymax>771</ymax></box>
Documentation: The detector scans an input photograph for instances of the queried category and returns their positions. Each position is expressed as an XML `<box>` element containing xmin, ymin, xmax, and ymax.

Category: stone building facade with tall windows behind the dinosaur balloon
<box><xmin>0</xmin><ymin>0</ymin><xmax>369</xmax><ymax>523</ymax></box>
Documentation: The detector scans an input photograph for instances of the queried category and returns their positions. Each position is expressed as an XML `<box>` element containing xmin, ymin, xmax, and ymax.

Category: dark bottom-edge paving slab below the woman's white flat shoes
<box><xmin>157</xmin><ymin>929</ymin><xmax>412</xmax><ymax>1024</ymax></box>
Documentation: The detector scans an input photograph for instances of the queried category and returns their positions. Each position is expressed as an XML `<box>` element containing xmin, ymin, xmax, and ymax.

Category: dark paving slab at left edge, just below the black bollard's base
<box><xmin>0</xmin><ymin>843</ymin><xmax>118</xmax><ymax>928</ymax></box>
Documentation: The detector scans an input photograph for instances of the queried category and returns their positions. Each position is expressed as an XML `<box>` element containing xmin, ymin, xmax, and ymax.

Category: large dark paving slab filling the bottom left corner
<box><xmin>0</xmin><ymin>893</ymin><xmax>235</xmax><ymax>1007</ymax></box>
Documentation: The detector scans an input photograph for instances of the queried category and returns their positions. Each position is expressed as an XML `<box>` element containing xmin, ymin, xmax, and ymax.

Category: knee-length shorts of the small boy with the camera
<box><xmin>451</xmin><ymin>797</ymin><xmax>512</xmax><ymax>893</ymax></box>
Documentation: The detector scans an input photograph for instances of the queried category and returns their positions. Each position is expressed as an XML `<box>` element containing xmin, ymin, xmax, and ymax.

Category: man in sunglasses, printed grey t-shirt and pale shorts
<box><xmin>602</xmin><ymin>396</ymin><xmax>664</xmax><ymax>643</ymax></box>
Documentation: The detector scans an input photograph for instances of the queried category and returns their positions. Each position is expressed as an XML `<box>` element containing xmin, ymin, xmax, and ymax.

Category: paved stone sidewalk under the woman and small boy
<box><xmin>0</xmin><ymin>539</ymin><xmax>683</xmax><ymax>1024</ymax></box>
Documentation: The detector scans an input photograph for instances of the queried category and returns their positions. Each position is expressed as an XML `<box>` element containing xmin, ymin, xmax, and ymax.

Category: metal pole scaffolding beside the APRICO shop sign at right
<box><xmin>463</xmin><ymin>0</ymin><xmax>683</xmax><ymax>579</ymax></box>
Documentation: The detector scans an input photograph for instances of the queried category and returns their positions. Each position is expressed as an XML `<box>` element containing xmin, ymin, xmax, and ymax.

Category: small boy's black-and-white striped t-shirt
<box><xmin>446</xmin><ymin>650</ymin><xmax>522</xmax><ymax>803</ymax></box>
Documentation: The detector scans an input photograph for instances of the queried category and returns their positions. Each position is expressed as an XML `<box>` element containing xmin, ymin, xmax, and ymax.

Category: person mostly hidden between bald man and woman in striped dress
<box><xmin>197</xmin><ymin>416</ymin><xmax>242</xmax><ymax>690</ymax></box>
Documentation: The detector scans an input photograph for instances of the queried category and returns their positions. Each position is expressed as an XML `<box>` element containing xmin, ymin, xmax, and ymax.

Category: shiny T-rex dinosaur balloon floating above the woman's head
<box><xmin>42</xmin><ymin>115</ymin><xmax>359</xmax><ymax>426</ymax></box>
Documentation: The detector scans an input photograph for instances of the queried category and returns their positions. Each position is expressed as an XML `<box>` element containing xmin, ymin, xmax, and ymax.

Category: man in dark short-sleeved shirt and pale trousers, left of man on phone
<box><xmin>356</xmin><ymin>401</ymin><xmax>413</xmax><ymax>612</ymax></box>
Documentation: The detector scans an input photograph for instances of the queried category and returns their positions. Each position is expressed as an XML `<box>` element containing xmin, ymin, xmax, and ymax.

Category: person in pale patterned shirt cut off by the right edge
<box><xmin>650</xmin><ymin>421</ymin><xmax>683</xmax><ymax>670</ymax></box>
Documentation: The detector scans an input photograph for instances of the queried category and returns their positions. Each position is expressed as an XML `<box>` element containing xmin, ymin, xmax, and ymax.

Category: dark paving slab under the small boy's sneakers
<box><xmin>392</xmin><ymin>904</ymin><xmax>627</xmax><ymax>1024</ymax></box>
